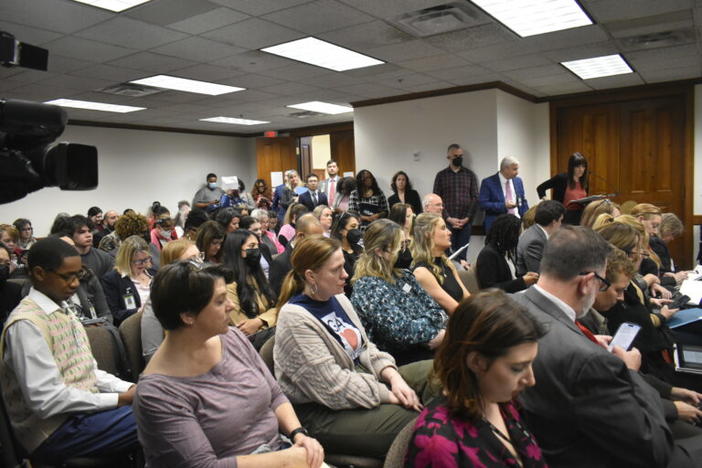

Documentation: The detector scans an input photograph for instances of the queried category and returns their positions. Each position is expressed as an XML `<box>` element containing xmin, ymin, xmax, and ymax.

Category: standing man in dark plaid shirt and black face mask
<box><xmin>432</xmin><ymin>143</ymin><xmax>478</xmax><ymax>261</ymax></box>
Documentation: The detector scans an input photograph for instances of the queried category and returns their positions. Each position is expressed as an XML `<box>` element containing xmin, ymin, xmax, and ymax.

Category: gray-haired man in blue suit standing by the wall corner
<box><xmin>478</xmin><ymin>157</ymin><xmax>529</xmax><ymax>232</ymax></box>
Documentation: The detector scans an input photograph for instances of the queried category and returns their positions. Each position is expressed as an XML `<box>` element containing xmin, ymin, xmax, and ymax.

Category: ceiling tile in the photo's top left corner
<box><xmin>0</xmin><ymin>0</ymin><xmax>114</xmax><ymax>34</ymax></box>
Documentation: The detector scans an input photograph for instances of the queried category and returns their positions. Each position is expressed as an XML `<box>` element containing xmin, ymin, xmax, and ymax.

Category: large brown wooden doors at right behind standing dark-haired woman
<box><xmin>552</xmin><ymin>94</ymin><xmax>692</xmax><ymax>266</ymax></box>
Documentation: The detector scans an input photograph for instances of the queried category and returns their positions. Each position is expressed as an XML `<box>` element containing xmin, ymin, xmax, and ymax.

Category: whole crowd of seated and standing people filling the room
<box><xmin>0</xmin><ymin>144</ymin><xmax>702</xmax><ymax>468</ymax></box>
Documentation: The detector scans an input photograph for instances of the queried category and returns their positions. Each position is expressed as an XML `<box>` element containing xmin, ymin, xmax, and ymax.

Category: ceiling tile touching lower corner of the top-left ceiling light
<box><xmin>77</xmin><ymin>16</ymin><xmax>187</xmax><ymax>49</ymax></box>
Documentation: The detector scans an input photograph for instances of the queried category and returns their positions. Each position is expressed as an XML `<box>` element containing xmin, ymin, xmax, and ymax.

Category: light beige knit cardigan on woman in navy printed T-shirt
<box><xmin>273</xmin><ymin>294</ymin><xmax>396</xmax><ymax>410</ymax></box>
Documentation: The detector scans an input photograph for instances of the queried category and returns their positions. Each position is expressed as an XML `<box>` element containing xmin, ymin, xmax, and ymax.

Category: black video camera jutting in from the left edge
<box><xmin>0</xmin><ymin>32</ymin><xmax>98</xmax><ymax>203</ymax></box>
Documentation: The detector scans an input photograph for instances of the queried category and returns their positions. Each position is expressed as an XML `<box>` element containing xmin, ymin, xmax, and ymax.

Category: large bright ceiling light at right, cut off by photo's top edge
<box><xmin>471</xmin><ymin>0</ymin><xmax>592</xmax><ymax>37</ymax></box>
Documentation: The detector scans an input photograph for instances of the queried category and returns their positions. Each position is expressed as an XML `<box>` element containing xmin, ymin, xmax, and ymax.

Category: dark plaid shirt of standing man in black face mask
<box><xmin>434</xmin><ymin>167</ymin><xmax>478</xmax><ymax>221</ymax></box>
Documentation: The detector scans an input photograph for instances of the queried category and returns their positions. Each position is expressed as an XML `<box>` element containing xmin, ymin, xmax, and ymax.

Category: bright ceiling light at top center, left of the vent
<box><xmin>261</xmin><ymin>37</ymin><xmax>385</xmax><ymax>71</ymax></box>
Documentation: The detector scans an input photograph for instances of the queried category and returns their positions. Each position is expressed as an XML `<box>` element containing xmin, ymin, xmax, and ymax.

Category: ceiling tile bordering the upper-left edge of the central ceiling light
<box><xmin>203</xmin><ymin>18</ymin><xmax>303</xmax><ymax>49</ymax></box>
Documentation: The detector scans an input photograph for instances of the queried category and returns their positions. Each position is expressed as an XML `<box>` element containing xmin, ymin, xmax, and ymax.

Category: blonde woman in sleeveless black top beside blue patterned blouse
<box><xmin>412</xmin><ymin>213</ymin><xmax>470</xmax><ymax>315</ymax></box>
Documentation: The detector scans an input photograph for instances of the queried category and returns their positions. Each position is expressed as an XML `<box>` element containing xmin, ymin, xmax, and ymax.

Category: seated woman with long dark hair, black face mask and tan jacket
<box><xmin>222</xmin><ymin>229</ymin><xmax>278</xmax><ymax>349</ymax></box>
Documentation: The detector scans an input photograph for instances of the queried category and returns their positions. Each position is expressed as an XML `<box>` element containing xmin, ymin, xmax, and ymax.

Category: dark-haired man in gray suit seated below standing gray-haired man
<box><xmin>516</xmin><ymin>200</ymin><xmax>565</xmax><ymax>276</ymax></box>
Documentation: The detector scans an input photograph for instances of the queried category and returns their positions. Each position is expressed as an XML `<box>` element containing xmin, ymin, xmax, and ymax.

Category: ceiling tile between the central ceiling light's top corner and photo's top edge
<box><xmin>263</xmin><ymin>0</ymin><xmax>374</xmax><ymax>34</ymax></box>
